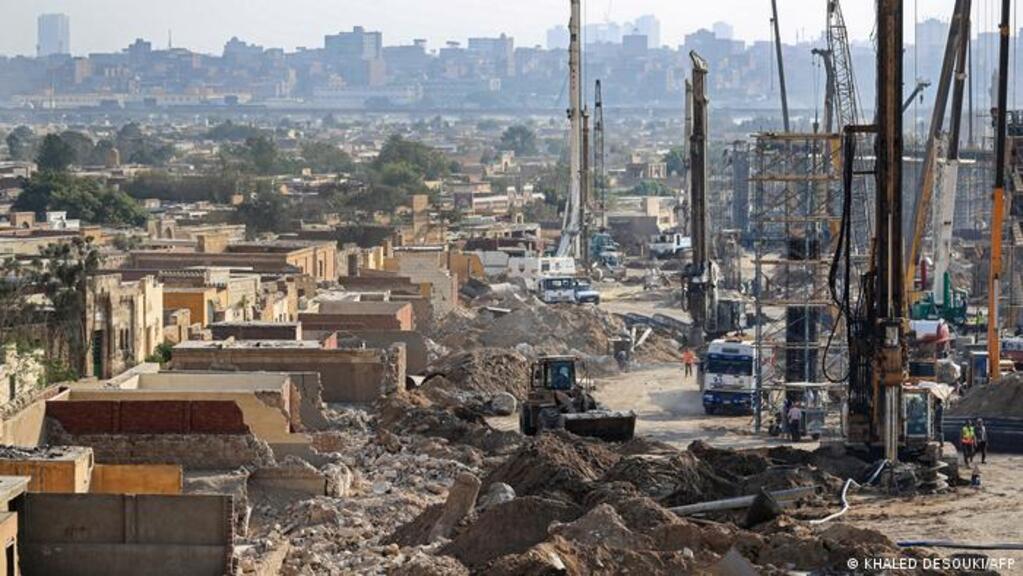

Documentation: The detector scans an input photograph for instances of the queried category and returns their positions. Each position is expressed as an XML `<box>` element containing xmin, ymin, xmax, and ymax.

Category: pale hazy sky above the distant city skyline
<box><xmin>0</xmin><ymin>0</ymin><xmax>1015</xmax><ymax>54</ymax></box>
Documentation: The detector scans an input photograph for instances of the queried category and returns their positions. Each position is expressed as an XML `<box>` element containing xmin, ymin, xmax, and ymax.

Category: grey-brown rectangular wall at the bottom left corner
<box><xmin>18</xmin><ymin>494</ymin><xmax>234</xmax><ymax>576</ymax></box>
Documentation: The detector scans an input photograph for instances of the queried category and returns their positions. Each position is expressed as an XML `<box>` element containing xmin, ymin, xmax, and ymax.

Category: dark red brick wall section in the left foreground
<box><xmin>46</xmin><ymin>400</ymin><xmax>249</xmax><ymax>434</ymax></box>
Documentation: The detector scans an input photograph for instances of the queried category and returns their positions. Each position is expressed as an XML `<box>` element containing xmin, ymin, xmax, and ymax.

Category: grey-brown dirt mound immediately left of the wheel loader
<box><xmin>422</xmin><ymin>348</ymin><xmax>529</xmax><ymax>400</ymax></box>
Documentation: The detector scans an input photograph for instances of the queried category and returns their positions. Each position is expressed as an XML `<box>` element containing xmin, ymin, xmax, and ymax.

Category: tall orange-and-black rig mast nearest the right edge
<box><xmin>987</xmin><ymin>0</ymin><xmax>1010</xmax><ymax>382</ymax></box>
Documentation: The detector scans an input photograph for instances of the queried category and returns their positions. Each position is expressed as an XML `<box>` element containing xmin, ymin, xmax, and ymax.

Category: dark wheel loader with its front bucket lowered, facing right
<box><xmin>519</xmin><ymin>356</ymin><xmax>636</xmax><ymax>442</ymax></box>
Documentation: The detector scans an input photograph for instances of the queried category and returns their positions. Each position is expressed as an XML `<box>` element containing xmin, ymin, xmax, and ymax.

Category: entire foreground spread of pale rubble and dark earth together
<box><xmin>230</xmin><ymin>384</ymin><xmax>957</xmax><ymax>576</ymax></box>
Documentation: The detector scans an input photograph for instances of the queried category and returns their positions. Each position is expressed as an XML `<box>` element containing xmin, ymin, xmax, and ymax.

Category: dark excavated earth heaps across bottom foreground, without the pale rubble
<box><xmin>385</xmin><ymin>433</ymin><xmax>953</xmax><ymax>575</ymax></box>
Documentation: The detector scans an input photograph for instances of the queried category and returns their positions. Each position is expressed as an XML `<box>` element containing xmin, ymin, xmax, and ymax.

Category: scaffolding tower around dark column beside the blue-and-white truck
<box><xmin>750</xmin><ymin>133</ymin><xmax>848</xmax><ymax>388</ymax></box>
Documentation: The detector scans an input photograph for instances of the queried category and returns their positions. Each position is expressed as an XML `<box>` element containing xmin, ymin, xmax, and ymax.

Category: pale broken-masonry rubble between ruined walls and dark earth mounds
<box><xmin>238</xmin><ymin>409</ymin><xmax>495</xmax><ymax>576</ymax></box>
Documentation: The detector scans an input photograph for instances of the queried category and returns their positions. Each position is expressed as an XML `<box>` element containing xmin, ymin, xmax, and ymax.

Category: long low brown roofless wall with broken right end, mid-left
<box><xmin>172</xmin><ymin>348</ymin><xmax>405</xmax><ymax>402</ymax></box>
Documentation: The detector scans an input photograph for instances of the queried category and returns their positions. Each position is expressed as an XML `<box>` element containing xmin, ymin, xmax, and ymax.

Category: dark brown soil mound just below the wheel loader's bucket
<box><xmin>483</xmin><ymin>432</ymin><xmax>619</xmax><ymax>502</ymax></box>
